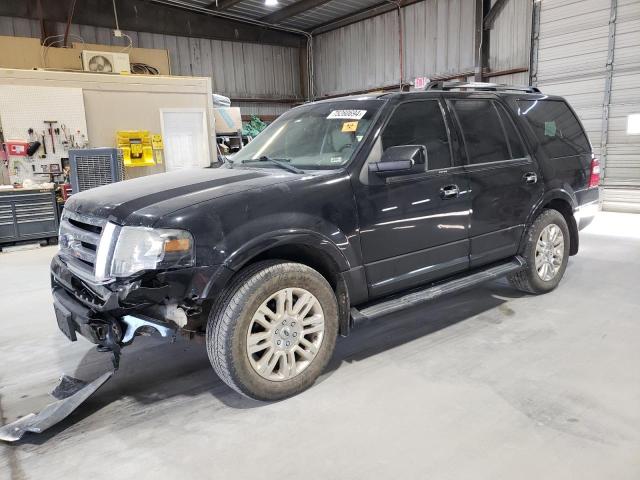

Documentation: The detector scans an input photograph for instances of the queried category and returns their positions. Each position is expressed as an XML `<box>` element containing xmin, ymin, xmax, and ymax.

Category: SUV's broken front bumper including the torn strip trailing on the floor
<box><xmin>0</xmin><ymin>254</ymin><xmax>231</xmax><ymax>442</ymax></box>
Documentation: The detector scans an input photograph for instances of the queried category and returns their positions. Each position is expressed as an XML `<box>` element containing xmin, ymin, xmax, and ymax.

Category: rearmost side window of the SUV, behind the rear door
<box><xmin>518</xmin><ymin>100</ymin><xmax>591</xmax><ymax>158</ymax></box>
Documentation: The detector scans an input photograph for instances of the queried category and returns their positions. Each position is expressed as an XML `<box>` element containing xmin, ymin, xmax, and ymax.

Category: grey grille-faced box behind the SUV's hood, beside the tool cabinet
<box><xmin>71</xmin><ymin>148</ymin><xmax>124</xmax><ymax>193</ymax></box>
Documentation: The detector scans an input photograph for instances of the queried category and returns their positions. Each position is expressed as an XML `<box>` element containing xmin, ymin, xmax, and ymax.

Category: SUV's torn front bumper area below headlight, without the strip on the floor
<box><xmin>51</xmin><ymin>255</ymin><xmax>224</xmax><ymax>368</ymax></box>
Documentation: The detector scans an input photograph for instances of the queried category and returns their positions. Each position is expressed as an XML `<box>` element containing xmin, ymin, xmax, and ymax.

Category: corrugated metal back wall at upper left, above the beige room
<box><xmin>0</xmin><ymin>17</ymin><xmax>302</xmax><ymax>114</ymax></box>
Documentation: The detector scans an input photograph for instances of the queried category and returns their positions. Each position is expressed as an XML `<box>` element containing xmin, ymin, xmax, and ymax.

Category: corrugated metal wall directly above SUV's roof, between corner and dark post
<box><xmin>314</xmin><ymin>0</ymin><xmax>475</xmax><ymax>97</ymax></box>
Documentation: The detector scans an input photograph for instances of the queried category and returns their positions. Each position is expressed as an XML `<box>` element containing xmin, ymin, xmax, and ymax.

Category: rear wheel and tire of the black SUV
<box><xmin>509</xmin><ymin>209</ymin><xmax>571</xmax><ymax>294</ymax></box>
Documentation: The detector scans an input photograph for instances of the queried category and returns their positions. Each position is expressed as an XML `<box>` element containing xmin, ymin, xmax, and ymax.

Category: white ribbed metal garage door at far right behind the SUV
<box><xmin>537</xmin><ymin>0</ymin><xmax>640</xmax><ymax>211</ymax></box>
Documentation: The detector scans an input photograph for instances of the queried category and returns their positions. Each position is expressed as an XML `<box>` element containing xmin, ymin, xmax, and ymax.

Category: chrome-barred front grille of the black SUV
<box><xmin>59</xmin><ymin>210</ymin><xmax>106</xmax><ymax>279</ymax></box>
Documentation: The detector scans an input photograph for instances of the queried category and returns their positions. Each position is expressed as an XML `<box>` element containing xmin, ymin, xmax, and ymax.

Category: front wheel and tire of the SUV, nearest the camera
<box><xmin>206</xmin><ymin>261</ymin><xmax>338</xmax><ymax>401</ymax></box>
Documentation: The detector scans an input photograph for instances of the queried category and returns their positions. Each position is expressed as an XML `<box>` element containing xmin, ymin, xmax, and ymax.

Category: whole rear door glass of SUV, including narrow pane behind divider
<box><xmin>451</xmin><ymin>99</ymin><xmax>525</xmax><ymax>165</ymax></box>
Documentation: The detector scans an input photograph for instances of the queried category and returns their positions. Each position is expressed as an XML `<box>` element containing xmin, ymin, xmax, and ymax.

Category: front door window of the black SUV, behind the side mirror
<box><xmin>382</xmin><ymin>100</ymin><xmax>451</xmax><ymax>170</ymax></box>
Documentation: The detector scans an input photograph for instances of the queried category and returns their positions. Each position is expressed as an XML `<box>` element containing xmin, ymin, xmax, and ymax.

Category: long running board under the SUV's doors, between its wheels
<box><xmin>351</xmin><ymin>256</ymin><xmax>526</xmax><ymax>323</ymax></box>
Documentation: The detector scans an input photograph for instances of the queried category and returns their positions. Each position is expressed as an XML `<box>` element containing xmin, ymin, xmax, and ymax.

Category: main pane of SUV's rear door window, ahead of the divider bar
<box><xmin>452</xmin><ymin>99</ymin><xmax>511</xmax><ymax>164</ymax></box>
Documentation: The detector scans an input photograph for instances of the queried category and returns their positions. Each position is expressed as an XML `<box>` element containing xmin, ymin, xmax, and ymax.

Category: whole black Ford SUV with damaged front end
<box><xmin>51</xmin><ymin>84</ymin><xmax>599</xmax><ymax>400</ymax></box>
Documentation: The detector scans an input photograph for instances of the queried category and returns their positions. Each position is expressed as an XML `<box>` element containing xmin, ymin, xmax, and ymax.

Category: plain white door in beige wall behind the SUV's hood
<box><xmin>160</xmin><ymin>108</ymin><xmax>211</xmax><ymax>172</ymax></box>
